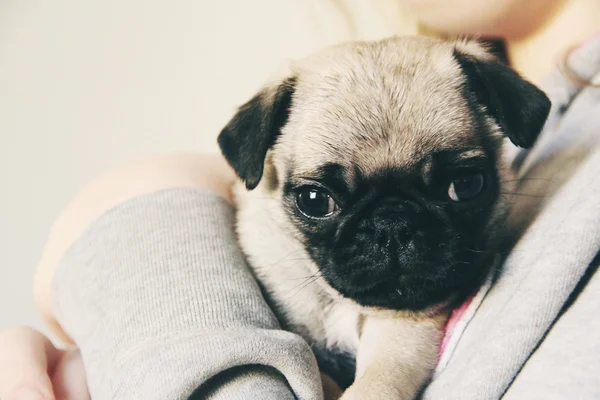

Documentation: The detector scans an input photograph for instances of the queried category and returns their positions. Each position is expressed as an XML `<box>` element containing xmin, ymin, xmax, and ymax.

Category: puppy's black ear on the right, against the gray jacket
<box><xmin>454</xmin><ymin>50</ymin><xmax>550</xmax><ymax>148</ymax></box>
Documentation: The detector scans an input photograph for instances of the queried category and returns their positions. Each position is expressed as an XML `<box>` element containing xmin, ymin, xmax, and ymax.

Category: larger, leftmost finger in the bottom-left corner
<box><xmin>0</xmin><ymin>328</ymin><xmax>63</xmax><ymax>400</ymax></box>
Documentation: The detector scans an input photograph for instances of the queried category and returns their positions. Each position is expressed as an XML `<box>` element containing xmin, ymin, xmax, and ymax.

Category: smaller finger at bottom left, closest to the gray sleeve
<box><xmin>52</xmin><ymin>350</ymin><xmax>90</xmax><ymax>400</ymax></box>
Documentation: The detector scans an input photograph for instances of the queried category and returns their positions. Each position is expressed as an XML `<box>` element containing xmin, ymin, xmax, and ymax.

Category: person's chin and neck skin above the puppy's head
<box><xmin>399</xmin><ymin>0</ymin><xmax>600</xmax><ymax>83</ymax></box>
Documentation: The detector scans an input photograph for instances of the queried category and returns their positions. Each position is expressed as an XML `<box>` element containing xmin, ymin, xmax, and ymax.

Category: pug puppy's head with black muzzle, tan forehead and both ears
<box><xmin>219</xmin><ymin>38</ymin><xmax>549</xmax><ymax>310</ymax></box>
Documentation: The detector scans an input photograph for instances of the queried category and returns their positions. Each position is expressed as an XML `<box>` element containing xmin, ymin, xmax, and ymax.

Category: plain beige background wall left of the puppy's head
<box><xmin>0</xmin><ymin>0</ymin><xmax>412</xmax><ymax>329</ymax></box>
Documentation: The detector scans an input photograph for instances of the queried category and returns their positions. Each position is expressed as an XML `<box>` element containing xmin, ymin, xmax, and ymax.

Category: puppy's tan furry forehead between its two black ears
<box><xmin>282</xmin><ymin>38</ymin><xmax>479</xmax><ymax>174</ymax></box>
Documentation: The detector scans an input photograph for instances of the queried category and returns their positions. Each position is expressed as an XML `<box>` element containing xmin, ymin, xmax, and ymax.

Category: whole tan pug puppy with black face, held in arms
<box><xmin>218</xmin><ymin>37</ymin><xmax>550</xmax><ymax>400</ymax></box>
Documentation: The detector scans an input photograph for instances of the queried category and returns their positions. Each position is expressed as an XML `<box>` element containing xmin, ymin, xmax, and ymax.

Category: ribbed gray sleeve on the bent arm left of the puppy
<box><xmin>52</xmin><ymin>188</ymin><xmax>323</xmax><ymax>400</ymax></box>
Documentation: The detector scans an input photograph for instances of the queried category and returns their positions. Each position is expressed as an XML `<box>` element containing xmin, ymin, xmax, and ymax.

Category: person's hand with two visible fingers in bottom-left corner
<box><xmin>0</xmin><ymin>328</ymin><xmax>90</xmax><ymax>400</ymax></box>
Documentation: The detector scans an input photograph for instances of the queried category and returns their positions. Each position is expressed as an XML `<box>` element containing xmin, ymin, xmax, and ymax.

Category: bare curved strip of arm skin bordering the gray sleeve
<box><xmin>34</xmin><ymin>154</ymin><xmax>235</xmax><ymax>344</ymax></box>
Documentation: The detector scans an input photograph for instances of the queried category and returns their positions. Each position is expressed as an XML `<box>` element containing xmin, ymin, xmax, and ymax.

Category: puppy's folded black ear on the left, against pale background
<box><xmin>217</xmin><ymin>78</ymin><xmax>296</xmax><ymax>190</ymax></box>
